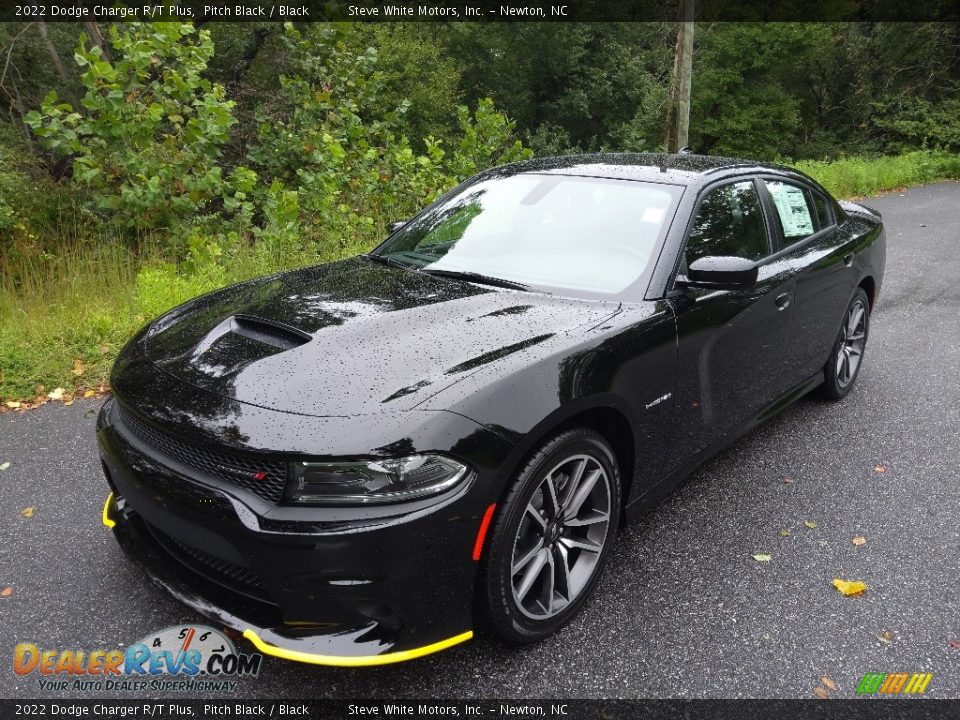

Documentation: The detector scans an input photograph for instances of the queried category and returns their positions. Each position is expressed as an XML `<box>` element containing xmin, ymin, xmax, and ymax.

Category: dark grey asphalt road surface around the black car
<box><xmin>0</xmin><ymin>183</ymin><xmax>960</xmax><ymax>699</ymax></box>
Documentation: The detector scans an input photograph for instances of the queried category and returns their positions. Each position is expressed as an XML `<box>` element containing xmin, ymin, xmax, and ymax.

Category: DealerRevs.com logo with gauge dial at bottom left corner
<box><xmin>13</xmin><ymin>625</ymin><xmax>263</xmax><ymax>692</ymax></box>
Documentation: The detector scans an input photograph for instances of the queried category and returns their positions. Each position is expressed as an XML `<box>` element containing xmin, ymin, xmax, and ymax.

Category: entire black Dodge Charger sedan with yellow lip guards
<box><xmin>97</xmin><ymin>155</ymin><xmax>885</xmax><ymax>665</ymax></box>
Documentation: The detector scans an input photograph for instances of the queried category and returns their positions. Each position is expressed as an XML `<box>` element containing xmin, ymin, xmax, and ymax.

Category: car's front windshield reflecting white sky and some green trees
<box><xmin>374</xmin><ymin>173</ymin><xmax>681</xmax><ymax>295</ymax></box>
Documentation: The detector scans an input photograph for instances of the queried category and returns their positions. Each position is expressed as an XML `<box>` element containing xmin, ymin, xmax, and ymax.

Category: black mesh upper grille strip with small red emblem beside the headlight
<box><xmin>120</xmin><ymin>406</ymin><xmax>287</xmax><ymax>503</ymax></box>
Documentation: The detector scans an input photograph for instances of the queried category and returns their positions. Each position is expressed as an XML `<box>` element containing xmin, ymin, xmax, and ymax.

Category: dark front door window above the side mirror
<box><xmin>687</xmin><ymin>180</ymin><xmax>769</xmax><ymax>265</ymax></box>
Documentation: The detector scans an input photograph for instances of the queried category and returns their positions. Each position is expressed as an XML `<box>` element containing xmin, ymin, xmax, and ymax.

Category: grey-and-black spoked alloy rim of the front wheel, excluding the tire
<box><xmin>510</xmin><ymin>455</ymin><xmax>611</xmax><ymax>620</ymax></box>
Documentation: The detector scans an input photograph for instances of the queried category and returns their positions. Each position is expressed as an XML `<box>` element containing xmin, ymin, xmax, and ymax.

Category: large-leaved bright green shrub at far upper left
<box><xmin>24</xmin><ymin>23</ymin><xmax>253</xmax><ymax>230</ymax></box>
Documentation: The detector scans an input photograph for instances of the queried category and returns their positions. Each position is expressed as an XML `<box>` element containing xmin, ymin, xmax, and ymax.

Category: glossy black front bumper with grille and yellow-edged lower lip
<box><xmin>98</xmin><ymin>402</ymin><xmax>502</xmax><ymax>666</ymax></box>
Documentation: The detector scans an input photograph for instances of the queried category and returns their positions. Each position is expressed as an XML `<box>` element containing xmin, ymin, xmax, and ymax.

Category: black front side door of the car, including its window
<box><xmin>670</xmin><ymin>178</ymin><xmax>796</xmax><ymax>467</ymax></box>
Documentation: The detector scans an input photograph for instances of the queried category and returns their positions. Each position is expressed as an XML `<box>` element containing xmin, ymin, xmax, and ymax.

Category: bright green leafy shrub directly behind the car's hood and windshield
<box><xmin>250</xmin><ymin>25</ymin><xmax>529</xmax><ymax>249</ymax></box>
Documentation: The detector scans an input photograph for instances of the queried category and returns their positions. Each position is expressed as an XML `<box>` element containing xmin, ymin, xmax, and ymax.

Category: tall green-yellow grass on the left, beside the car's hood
<box><xmin>0</xmin><ymin>228</ymin><xmax>344</xmax><ymax>407</ymax></box>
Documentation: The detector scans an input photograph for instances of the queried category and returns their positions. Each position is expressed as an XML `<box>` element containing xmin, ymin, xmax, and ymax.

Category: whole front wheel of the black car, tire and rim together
<box><xmin>478</xmin><ymin>429</ymin><xmax>621</xmax><ymax>644</ymax></box>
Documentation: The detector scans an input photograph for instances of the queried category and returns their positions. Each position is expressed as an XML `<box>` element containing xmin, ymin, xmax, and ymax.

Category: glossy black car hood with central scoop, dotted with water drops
<box><xmin>140</xmin><ymin>258</ymin><xmax>618</xmax><ymax>416</ymax></box>
